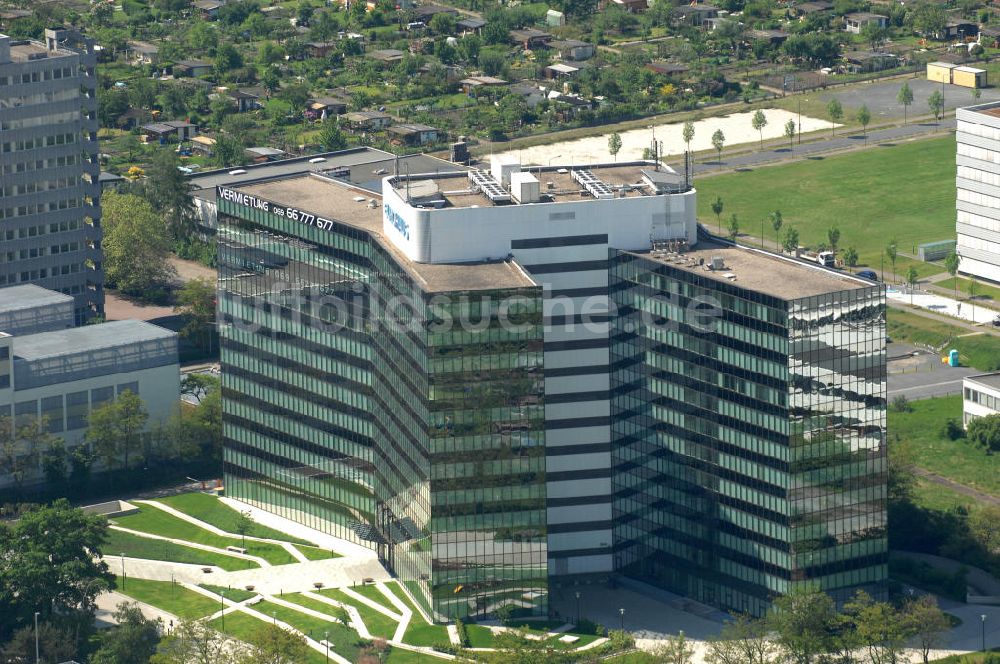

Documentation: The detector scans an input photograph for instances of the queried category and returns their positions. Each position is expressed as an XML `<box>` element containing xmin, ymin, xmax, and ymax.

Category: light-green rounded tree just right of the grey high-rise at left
<box><xmin>101</xmin><ymin>191</ymin><xmax>176</xmax><ymax>299</ymax></box>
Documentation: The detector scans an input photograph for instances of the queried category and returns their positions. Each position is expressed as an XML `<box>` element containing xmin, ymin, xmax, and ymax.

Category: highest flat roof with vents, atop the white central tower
<box><xmin>392</xmin><ymin>158</ymin><xmax>674</xmax><ymax>207</ymax></box>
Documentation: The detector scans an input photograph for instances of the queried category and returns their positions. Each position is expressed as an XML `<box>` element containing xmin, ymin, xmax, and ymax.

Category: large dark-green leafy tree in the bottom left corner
<box><xmin>0</xmin><ymin>499</ymin><xmax>114</xmax><ymax>643</ymax></box>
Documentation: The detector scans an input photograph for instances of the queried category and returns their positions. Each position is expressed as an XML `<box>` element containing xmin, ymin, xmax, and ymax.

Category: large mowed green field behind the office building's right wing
<box><xmin>695</xmin><ymin>136</ymin><xmax>955</xmax><ymax>279</ymax></box>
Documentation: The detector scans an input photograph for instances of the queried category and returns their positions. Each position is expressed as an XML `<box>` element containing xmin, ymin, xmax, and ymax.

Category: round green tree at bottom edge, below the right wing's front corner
<box><xmin>767</xmin><ymin>587</ymin><xmax>838</xmax><ymax>664</ymax></box>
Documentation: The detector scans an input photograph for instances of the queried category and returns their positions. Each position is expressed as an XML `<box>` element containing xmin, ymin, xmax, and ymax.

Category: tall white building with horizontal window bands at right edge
<box><xmin>955</xmin><ymin>102</ymin><xmax>1000</xmax><ymax>283</ymax></box>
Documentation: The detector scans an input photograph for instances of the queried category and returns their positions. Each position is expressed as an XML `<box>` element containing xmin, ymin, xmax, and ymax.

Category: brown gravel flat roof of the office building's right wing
<box><xmin>628</xmin><ymin>240</ymin><xmax>875</xmax><ymax>300</ymax></box>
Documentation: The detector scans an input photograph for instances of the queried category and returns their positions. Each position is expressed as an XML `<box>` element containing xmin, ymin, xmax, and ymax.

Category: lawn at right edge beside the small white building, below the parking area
<box><xmin>888</xmin><ymin>394</ymin><xmax>1000</xmax><ymax>496</ymax></box>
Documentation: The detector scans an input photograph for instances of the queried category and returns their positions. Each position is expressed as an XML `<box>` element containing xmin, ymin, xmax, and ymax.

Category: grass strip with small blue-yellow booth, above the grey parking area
<box><xmin>886</xmin><ymin>307</ymin><xmax>1000</xmax><ymax>371</ymax></box>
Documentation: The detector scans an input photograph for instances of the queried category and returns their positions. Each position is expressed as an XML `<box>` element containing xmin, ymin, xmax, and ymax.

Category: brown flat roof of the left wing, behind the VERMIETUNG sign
<box><xmin>233</xmin><ymin>174</ymin><xmax>537</xmax><ymax>293</ymax></box>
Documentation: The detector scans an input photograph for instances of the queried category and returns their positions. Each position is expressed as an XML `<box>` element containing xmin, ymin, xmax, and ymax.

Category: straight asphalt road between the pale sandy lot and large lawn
<box><xmin>688</xmin><ymin>118</ymin><xmax>955</xmax><ymax>175</ymax></box>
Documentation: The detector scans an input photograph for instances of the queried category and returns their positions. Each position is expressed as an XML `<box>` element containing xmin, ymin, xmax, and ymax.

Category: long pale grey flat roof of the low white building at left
<box><xmin>14</xmin><ymin>320</ymin><xmax>177</xmax><ymax>360</ymax></box>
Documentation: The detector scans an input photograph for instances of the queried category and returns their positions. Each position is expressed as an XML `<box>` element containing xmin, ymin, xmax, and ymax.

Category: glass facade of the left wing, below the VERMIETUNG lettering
<box><xmin>218</xmin><ymin>197</ymin><xmax>548</xmax><ymax>619</ymax></box>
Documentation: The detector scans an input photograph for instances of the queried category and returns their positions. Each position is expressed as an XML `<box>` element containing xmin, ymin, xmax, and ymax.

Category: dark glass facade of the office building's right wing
<box><xmin>610</xmin><ymin>251</ymin><xmax>888</xmax><ymax>615</ymax></box>
